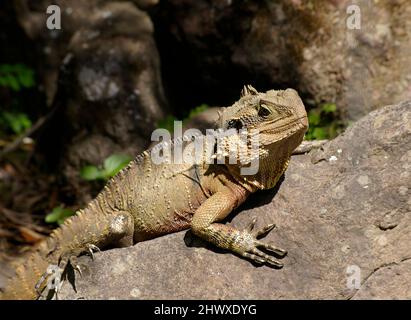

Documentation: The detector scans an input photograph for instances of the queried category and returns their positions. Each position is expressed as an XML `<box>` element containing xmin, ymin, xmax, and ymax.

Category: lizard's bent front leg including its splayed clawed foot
<box><xmin>191</xmin><ymin>186</ymin><xmax>286</xmax><ymax>268</ymax></box>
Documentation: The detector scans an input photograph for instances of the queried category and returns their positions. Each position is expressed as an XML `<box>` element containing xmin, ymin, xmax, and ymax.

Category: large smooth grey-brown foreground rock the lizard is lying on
<box><xmin>60</xmin><ymin>101</ymin><xmax>411</xmax><ymax>299</ymax></box>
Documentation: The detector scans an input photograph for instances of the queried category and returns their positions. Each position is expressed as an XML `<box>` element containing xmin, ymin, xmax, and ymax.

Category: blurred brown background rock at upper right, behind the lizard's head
<box><xmin>154</xmin><ymin>0</ymin><xmax>411</xmax><ymax>120</ymax></box>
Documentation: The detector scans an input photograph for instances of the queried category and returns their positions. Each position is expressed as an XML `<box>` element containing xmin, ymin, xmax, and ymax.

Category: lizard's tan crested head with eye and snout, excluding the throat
<box><xmin>219</xmin><ymin>85</ymin><xmax>308</xmax><ymax>151</ymax></box>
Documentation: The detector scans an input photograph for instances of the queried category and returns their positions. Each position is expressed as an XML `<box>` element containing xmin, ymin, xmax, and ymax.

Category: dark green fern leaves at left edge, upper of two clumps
<box><xmin>0</xmin><ymin>63</ymin><xmax>35</xmax><ymax>91</ymax></box>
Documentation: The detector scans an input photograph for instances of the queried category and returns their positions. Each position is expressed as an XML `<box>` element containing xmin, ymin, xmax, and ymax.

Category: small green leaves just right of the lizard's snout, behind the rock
<box><xmin>305</xmin><ymin>103</ymin><xmax>344</xmax><ymax>140</ymax></box>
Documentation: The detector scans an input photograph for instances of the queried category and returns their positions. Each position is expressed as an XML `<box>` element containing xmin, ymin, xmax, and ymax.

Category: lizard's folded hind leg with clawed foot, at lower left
<box><xmin>34</xmin><ymin>211</ymin><xmax>134</xmax><ymax>298</ymax></box>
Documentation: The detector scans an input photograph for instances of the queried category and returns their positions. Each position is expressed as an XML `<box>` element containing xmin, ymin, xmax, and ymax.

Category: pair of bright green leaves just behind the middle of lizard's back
<box><xmin>80</xmin><ymin>154</ymin><xmax>132</xmax><ymax>181</ymax></box>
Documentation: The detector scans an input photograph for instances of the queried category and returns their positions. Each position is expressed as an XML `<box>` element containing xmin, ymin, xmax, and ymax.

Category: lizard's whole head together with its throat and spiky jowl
<box><xmin>219</xmin><ymin>85</ymin><xmax>308</xmax><ymax>188</ymax></box>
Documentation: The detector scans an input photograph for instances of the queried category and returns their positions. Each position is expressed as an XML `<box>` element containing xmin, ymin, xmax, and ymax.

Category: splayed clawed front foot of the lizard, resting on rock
<box><xmin>235</xmin><ymin>219</ymin><xmax>287</xmax><ymax>268</ymax></box>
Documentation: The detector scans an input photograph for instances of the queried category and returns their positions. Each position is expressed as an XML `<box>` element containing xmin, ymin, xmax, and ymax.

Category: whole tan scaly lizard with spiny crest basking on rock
<box><xmin>2</xmin><ymin>86</ymin><xmax>308</xmax><ymax>299</ymax></box>
